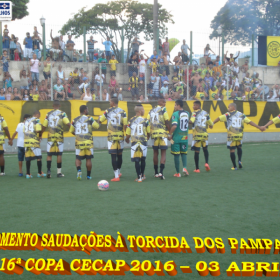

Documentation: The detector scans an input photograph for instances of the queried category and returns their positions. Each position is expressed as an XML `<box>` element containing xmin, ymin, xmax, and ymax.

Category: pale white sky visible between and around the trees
<box><xmin>4</xmin><ymin>0</ymin><xmax>248</xmax><ymax>55</ymax></box>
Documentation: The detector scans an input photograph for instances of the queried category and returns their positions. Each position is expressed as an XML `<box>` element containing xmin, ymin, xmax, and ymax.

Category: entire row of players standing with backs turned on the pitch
<box><xmin>0</xmin><ymin>98</ymin><xmax>280</xmax><ymax>183</ymax></box>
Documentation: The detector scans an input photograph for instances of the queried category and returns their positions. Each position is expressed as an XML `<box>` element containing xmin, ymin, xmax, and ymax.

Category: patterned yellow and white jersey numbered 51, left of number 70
<box><xmin>100</xmin><ymin>107</ymin><xmax>127</xmax><ymax>141</ymax></box>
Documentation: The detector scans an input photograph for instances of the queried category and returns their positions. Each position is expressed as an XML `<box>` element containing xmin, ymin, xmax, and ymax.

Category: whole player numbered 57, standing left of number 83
<box><xmin>42</xmin><ymin>100</ymin><xmax>71</xmax><ymax>178</ymax></box>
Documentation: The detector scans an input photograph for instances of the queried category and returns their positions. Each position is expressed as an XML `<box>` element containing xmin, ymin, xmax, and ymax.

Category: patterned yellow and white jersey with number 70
<box><xmin>126</xmin><ymin>116</ymin><xmax>150</xmax><ymax>146</ymax></box>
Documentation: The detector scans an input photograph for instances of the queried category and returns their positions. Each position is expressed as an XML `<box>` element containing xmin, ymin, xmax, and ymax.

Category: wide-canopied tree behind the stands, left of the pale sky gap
<box><xmin>60</xmin><ymin>0</ymin><xmax>174</xmax><ymax>61</ymax></box>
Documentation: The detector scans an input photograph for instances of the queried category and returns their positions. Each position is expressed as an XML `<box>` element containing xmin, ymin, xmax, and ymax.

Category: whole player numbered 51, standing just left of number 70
<box><xmin>98</xmin><ymin>98</ymin><xmax>127</xmax><ymax>182</ymax></box>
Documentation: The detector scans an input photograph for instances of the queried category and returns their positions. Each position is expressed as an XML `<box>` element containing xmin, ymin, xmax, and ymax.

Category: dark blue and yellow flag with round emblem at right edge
<box><xmin>258</xmin><ymin>36</ymin><xmax>280</xmax><ymax>66</ymax></box>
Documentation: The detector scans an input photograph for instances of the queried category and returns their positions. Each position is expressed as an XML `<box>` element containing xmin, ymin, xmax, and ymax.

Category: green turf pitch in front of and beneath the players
<box><xmin>0</xmin><ymin>143</ymin><xmax>280</xmax><ymax>279</ymax></box>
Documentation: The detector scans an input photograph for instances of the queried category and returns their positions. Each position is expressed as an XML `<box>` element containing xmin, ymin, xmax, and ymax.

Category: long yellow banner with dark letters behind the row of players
<box><xmin>0</xmin><ymin>100</ymin><xmax>280</xmax><ymax>138</ymax></box>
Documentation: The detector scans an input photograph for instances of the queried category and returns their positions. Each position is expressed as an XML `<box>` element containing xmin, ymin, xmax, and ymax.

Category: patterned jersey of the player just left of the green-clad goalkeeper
<box><xmin>147</xmin><ymin>106</ymin><xmax>169</xmax><ymax>138</ymax></box>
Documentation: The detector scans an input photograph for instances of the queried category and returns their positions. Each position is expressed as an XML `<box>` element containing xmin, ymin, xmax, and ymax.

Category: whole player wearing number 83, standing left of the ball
<box><xmin>70</xmin><ymin>105</ymin><xmax>99</xmax><ymax>180</ymax></box>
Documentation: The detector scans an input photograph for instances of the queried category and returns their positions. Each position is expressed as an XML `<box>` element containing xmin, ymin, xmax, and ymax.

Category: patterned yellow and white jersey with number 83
<box><xmin>70</xmin><ymin>115</ymin><xmax>99</xmax><ymax>150</ymax></box>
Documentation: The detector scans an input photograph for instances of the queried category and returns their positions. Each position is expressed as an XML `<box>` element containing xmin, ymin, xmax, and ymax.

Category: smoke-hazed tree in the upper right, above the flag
<box><xmin>210</xmin><ymin>0</ymin><xmax>280</xmax><ymax>45</ymax></box>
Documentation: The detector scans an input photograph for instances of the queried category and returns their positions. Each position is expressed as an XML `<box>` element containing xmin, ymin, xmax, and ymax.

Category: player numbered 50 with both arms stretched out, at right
<box><xmin>213</xmin><ymin>103</ymin><xmax>261</xmax><ymax>170</ymax></box>
